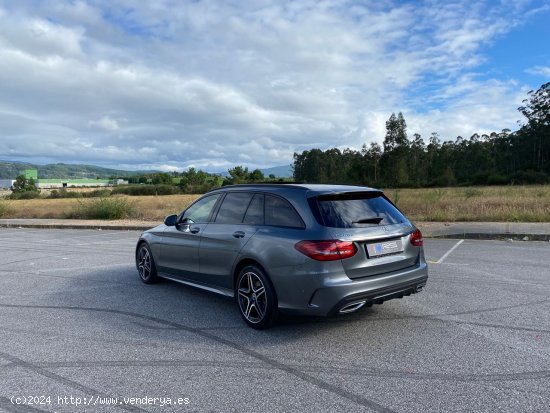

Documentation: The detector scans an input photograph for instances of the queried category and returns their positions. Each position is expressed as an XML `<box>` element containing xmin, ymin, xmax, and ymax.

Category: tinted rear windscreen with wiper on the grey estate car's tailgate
<box><xmin>317</xmin><ymin>192</ymin><xmax>407</xmax><ymax>228</ymax></box>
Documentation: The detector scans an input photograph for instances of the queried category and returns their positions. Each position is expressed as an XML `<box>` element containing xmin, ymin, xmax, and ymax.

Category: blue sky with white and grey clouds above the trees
<box><xmin>0</xmin><ymin>0</ymin><xmax>550</xmax><ymax>171</ymax></box>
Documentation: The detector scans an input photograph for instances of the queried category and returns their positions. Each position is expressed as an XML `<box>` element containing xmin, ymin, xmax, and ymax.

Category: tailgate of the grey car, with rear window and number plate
<box><xmin>308</xmin><ymin>191</ymin><xmax>421</xmax><ymax>279</ymax></box>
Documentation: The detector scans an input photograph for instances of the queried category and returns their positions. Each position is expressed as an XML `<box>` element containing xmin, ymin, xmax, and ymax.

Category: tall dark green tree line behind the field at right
<box><xmin>293</xmin><ymin>82</ymin><xmax>550</xmax><ymax>188</ymax></box>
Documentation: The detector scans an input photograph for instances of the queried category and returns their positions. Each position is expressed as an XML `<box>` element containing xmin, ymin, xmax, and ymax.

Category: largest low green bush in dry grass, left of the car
<box><xmin>67</xmin><ymin>198</ymin><xmax>136</xmax><ymax>219</ymax></box>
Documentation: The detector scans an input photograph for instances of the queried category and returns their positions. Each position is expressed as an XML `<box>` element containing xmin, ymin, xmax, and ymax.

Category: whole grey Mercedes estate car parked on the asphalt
<box><xmin>136</xmin><ymin>184</ymin><xmax>428</xmax><ymax>329</ymax></box>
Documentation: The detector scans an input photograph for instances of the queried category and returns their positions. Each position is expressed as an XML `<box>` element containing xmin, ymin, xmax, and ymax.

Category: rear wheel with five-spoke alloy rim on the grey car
<box><xmin>236</xmin><ymin>265</ymin><xmax>278</xmax><ymax>330</ymax></box>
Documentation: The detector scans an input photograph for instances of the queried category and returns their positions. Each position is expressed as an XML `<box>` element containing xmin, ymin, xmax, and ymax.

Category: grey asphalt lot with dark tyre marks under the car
<box><xmin>0</xmin><ymin>228</ymin><xmax>550</xmax><ymax>413</ymax></box>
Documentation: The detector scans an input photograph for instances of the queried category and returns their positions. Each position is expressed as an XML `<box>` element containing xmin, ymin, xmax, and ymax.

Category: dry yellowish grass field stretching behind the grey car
<box><xmin>0</xmin><ymin>185</ymin><xmax>550</xmax><ymax>222</ymax></box>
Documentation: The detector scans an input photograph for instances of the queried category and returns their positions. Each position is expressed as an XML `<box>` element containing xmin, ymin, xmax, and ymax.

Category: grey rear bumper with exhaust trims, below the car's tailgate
<box><xmin>280</xmin><ymin>260</ymin><xmax>428</xmax><ymax>316</ymax></box>
